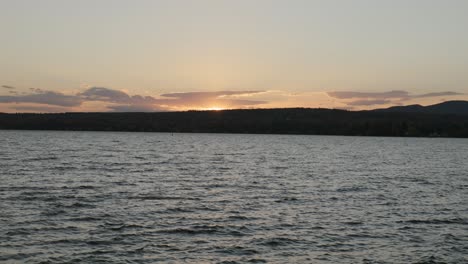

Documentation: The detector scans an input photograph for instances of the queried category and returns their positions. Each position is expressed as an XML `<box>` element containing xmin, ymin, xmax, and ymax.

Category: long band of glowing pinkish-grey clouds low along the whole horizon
<box><xmin>0</xmin><ymin>85</ymin><xmax>462</xmax><ymax>112</ymax></box>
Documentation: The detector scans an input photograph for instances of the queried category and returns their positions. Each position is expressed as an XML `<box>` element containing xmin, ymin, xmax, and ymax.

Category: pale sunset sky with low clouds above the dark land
<box><xmin>0</xmin><ymin>0</ymin><xmax>468</xmax><ymax>112</ymax></box>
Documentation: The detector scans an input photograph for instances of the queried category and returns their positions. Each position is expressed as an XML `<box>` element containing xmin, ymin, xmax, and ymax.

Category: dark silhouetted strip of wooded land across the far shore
<box><xmin>0</xmin><ymin>101</ymin><xmax>468</xmax><ymax>138</ymax></box>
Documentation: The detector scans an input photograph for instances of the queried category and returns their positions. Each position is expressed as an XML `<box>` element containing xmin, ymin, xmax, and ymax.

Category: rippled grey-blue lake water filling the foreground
<box><xmin>0</xmin><ymin>131</ymin><xmax>468</xmax><ymax>263</ymax></box>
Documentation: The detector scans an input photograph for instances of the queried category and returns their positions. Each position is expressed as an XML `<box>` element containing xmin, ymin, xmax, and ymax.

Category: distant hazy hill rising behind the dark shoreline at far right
<box><xmin>373</xmin><ymin>101</ymin><xmax>468</xmax><ymax>115</ymax></box>
